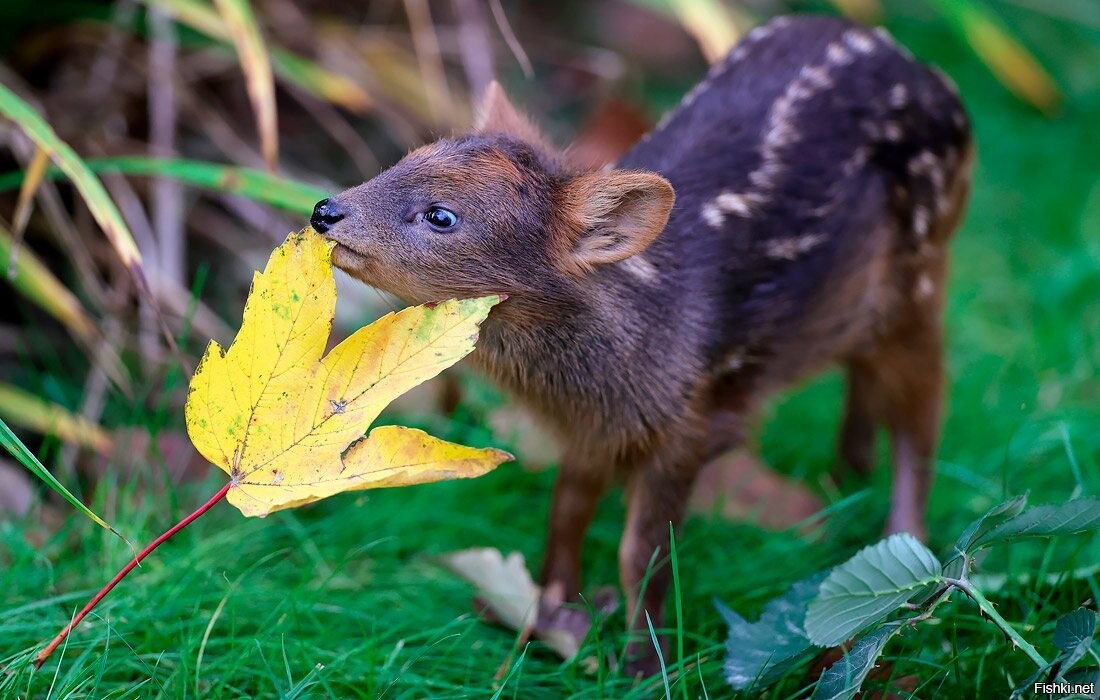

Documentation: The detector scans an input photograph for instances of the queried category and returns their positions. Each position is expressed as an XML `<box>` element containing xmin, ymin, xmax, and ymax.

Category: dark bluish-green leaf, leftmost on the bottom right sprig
<box><xmin>714</xmin><ymin>572</ymin><xmax>825</xmax><ymax>690</ymax></box>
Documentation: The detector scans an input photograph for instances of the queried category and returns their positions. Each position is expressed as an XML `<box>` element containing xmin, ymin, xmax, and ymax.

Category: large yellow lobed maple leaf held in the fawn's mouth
<box><xmin>185</xmin><ymin>228</ymin><xmax>512</xmax><ymax>516</ymax></box>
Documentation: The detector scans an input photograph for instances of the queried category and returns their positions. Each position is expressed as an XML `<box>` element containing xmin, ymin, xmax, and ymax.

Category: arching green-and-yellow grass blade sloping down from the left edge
<box><xmin>0</xmin><ymin>84</ymin><xmax>141</xmax><ymax>271</ymax></box>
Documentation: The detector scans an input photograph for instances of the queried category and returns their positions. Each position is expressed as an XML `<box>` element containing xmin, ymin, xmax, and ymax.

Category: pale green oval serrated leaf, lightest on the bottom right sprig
<box><xmin>806</xmin><ymin>533</ymin><xmax>943</xmax><ymax>646</ymax></box>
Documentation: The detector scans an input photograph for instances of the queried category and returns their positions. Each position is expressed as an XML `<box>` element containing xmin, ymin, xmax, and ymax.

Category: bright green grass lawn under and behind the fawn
<box><xmin>0</xmin><ymin>5</ymin><xmax>1100</xmax><ymax>700</ymax></box>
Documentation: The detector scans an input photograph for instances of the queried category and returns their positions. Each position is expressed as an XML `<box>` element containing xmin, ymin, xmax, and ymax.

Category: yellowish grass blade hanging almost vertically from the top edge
<box><xmin>215</xmin><ymin>0</ymin><xmax>278</xmax><ymax>173</ymax></box>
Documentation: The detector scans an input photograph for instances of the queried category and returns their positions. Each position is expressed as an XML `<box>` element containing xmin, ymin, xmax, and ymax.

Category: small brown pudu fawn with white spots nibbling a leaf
<box><xmin>311</xmin><ymin>17</ymin><xmax>971</xmax><ymax>671</ymax></box>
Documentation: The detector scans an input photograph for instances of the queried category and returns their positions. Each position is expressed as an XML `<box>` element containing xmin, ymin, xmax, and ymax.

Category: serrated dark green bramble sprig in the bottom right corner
<box><xmin>717</xmin><ymin>496</ymin><xmax>1100</xmax><ymax>700</ymax></box>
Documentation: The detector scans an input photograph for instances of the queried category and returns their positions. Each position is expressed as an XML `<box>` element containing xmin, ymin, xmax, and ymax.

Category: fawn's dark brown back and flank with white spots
<box><xmin>618</xmin><ymin>17</ymin><xmax>969</xmax><ymax>387</ymax></box>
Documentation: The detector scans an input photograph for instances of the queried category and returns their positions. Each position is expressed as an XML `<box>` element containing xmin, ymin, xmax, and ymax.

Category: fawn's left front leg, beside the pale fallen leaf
<box><xmin>537</xmin><ymin>460</ymin><xmax>607</xmax><ymax>642</ymax></box>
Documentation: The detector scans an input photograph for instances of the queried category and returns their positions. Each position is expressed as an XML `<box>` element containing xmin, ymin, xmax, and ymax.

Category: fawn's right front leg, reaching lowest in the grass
<box><xmin>619</xmin><ymin>460</ymin><xmax>699</xmax><ymax>676</ymax></box>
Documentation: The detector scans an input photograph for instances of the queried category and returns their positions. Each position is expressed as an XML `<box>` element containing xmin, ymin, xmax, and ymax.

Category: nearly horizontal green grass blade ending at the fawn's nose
<box><xmin>0</xmin><ymin>156</ymin><xmax>331</xmax><ymax>216</ymax></box>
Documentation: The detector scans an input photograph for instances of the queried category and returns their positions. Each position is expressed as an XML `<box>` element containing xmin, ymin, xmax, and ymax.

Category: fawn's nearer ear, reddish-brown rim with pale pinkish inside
<box><xmin>561</xmin><ymin>169</ymin><xmax>675</xmax><ymax>270</ymax></box>
